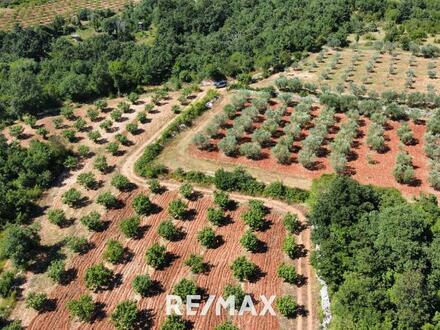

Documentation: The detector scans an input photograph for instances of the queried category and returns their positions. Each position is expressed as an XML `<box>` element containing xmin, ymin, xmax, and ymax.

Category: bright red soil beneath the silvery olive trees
<box><xmin>189</xmin><ymin>104</ymin><xmax>440</xmax><ymax>197</ymax></box>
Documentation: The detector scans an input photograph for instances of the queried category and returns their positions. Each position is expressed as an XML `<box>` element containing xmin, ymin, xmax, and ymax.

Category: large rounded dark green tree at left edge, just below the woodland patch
<box><xmin>0</xmin><ymin>224</ymin><xmax>40</xmax><ymax>268</ymax></box>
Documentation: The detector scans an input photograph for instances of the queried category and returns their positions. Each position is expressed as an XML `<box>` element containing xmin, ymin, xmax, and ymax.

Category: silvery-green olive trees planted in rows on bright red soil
<box><xmin>193</xmin><ymin>86</ymin><xmax>439</xmax><ymax>189</ymax></box>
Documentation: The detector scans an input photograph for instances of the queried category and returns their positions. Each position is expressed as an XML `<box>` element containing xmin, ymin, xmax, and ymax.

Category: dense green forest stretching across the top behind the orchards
<box><xmin>0</xmin><ymin>0</ymin><xmax>440</xmax><ymax>119</ymax></box>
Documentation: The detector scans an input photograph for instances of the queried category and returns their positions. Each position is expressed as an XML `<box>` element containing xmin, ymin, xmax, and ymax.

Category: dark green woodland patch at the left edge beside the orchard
<box><xmin>0</xmin><ymin>136</ymin><xmax>68</xmax><ymax>227</ymax></box>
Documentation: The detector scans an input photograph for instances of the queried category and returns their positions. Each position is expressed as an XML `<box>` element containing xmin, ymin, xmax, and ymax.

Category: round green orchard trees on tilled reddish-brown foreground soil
<box><xmin>9</xmin><ymin>184</ymin><xmax>306</xmax><ymax>329</ymax></box>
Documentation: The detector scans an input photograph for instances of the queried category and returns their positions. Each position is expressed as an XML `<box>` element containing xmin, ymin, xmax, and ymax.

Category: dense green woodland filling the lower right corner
<box><xmin>309</xmin><ymin>176</ymin><xmax>440</xmax><ymax>330</ymax></box>
